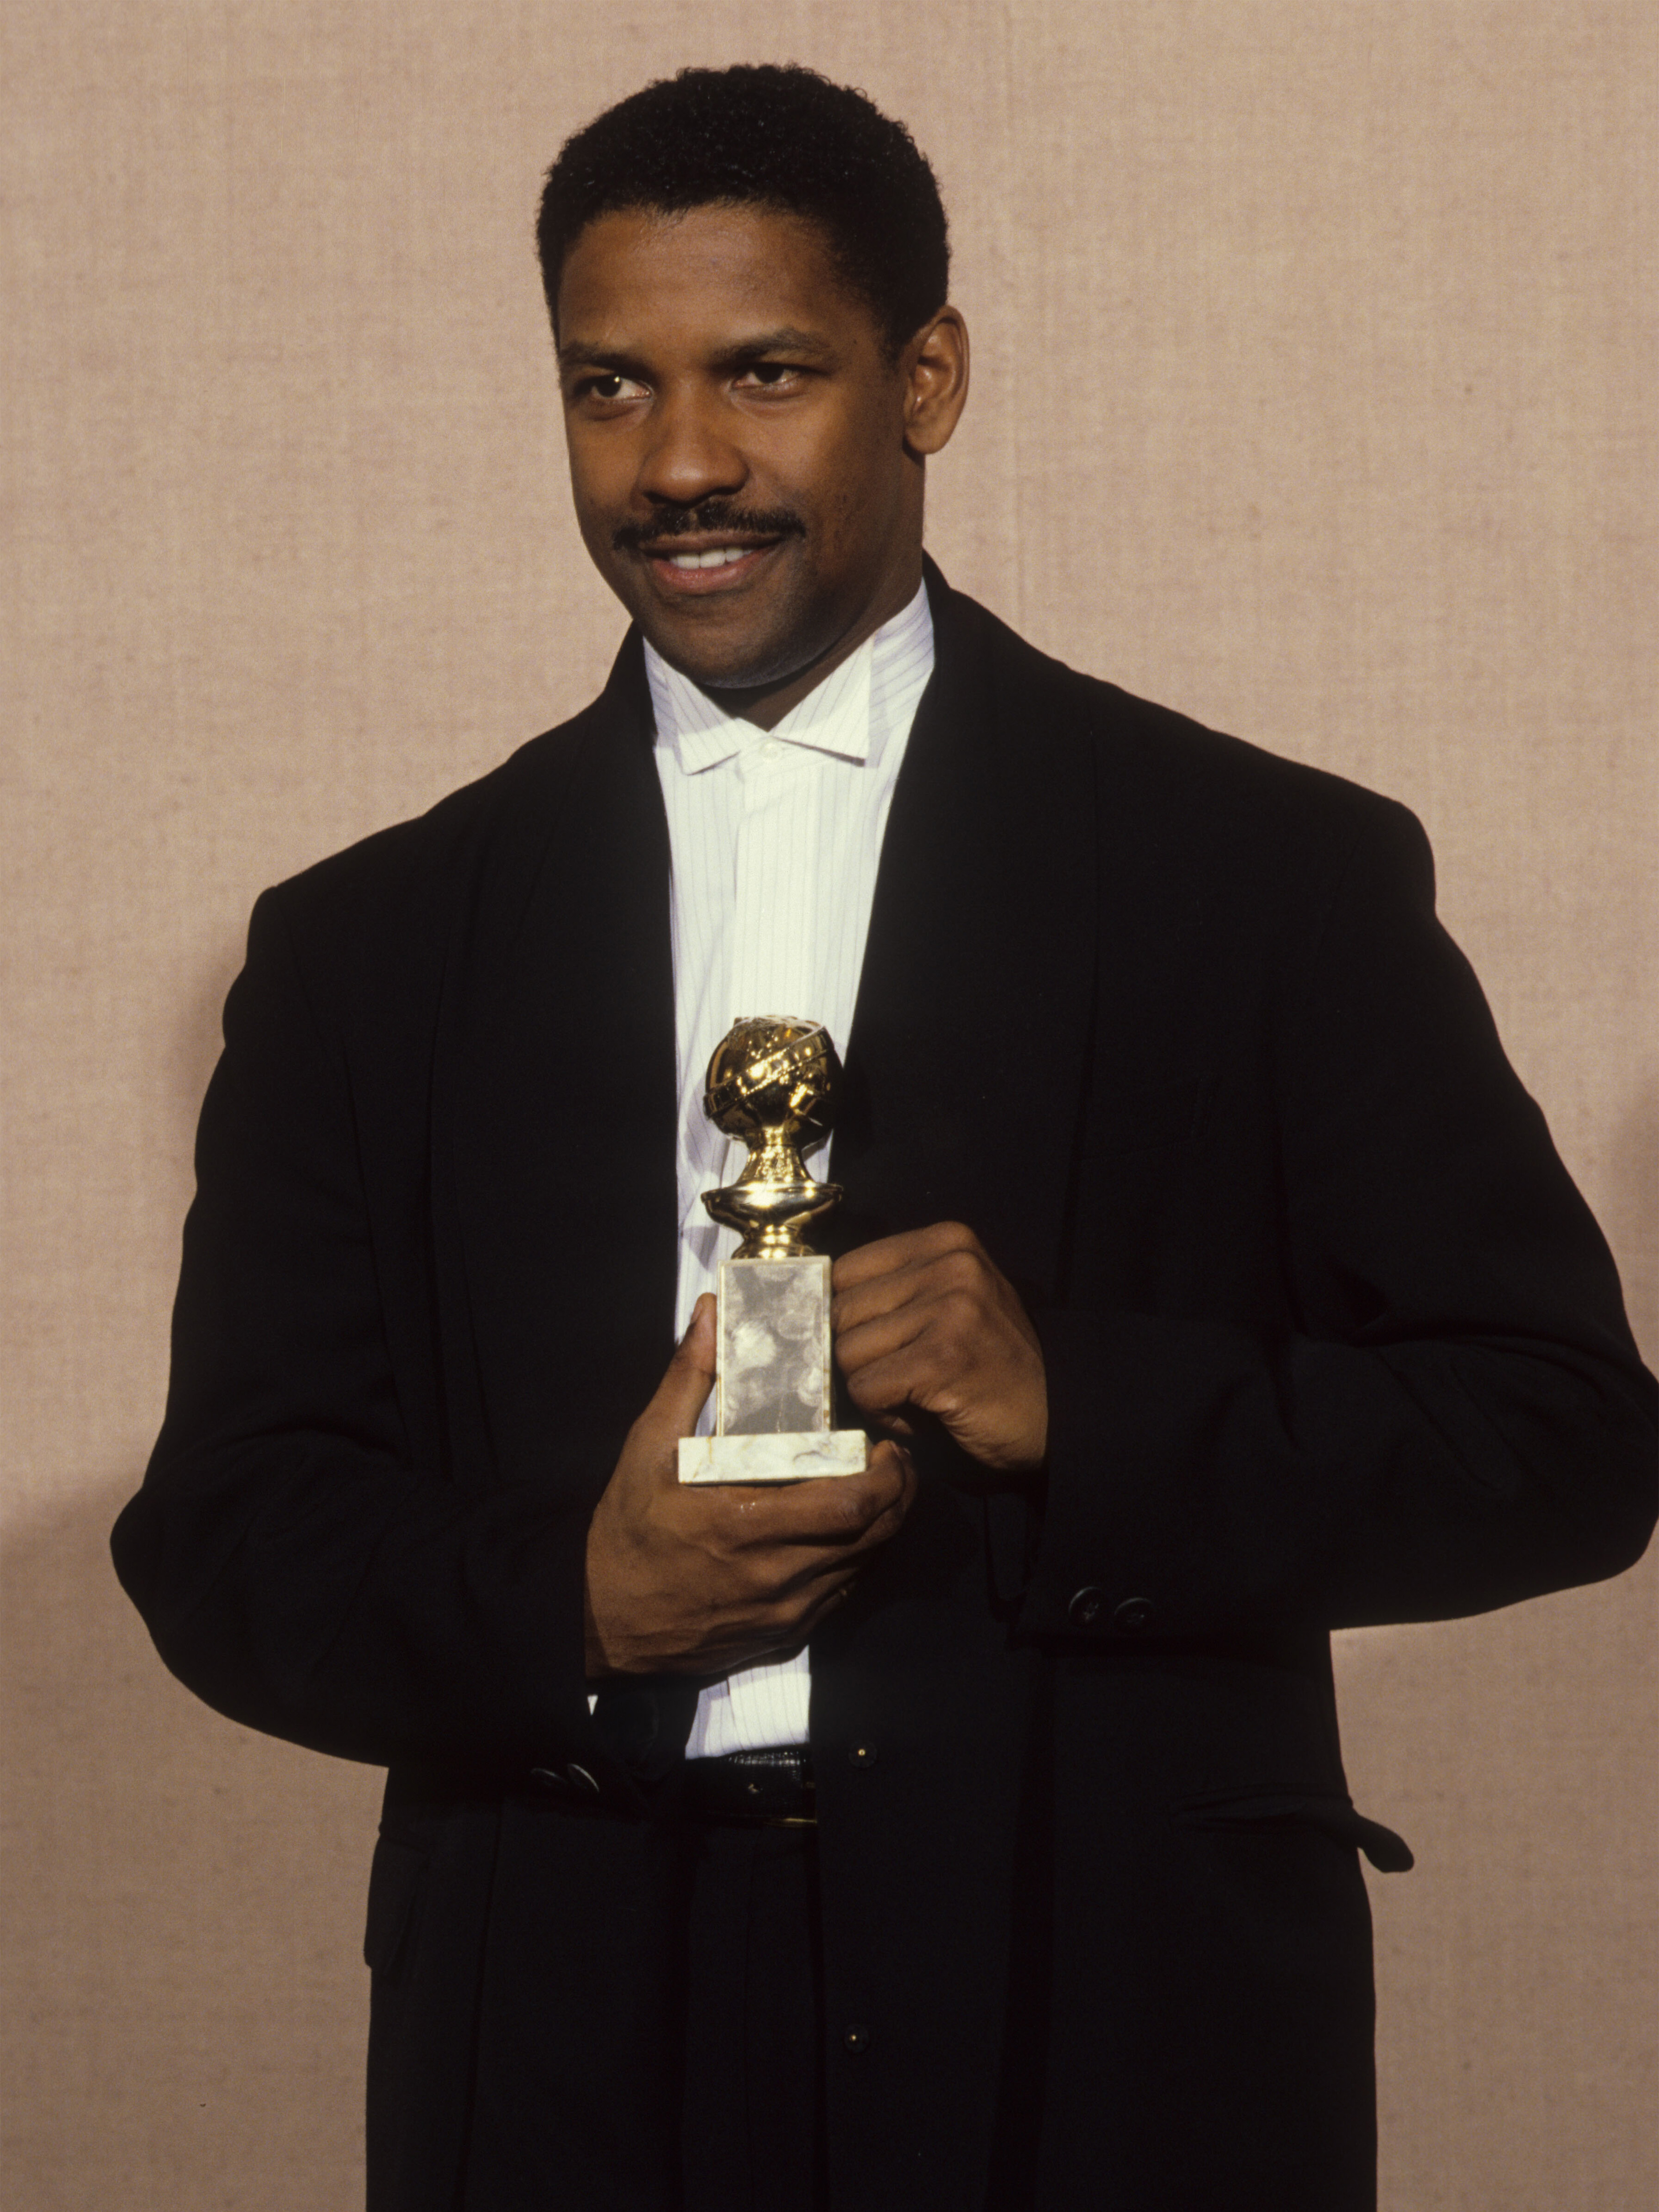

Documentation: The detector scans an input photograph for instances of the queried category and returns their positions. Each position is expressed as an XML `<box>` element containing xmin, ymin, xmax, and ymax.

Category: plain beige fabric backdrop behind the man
<box><xmin>0</xmin><ymin>0</ymin><xmax>1659</xmax><ymax>2212</ymax></box>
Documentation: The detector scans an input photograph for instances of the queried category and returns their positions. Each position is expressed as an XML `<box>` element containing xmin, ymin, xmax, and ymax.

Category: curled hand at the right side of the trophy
<box><xmin>832</xmin><ymin>1221</ymin><xmax>1049</xmax><ymax>1475</ymax></box>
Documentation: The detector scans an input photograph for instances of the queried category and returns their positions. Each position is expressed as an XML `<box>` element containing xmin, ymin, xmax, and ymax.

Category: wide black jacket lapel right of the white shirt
<box><xmin>834</xmin><ymin>562</ymin><xmax>1097</xmax><ymax>1296</ymax></box>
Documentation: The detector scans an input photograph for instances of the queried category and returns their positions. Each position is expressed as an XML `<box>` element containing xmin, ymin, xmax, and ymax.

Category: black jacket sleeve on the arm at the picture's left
<box><xmin>113</xmin><ymin>892</ymin><xmax>619</xmax><ymax>1772</ymax></box>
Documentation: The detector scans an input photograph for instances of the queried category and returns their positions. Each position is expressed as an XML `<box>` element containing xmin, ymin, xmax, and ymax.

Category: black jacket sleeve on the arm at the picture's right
<box><xmin>1020</xmin><ymin>805</ymin><xmax>1655</xmax><ymax>1639</ymax></box>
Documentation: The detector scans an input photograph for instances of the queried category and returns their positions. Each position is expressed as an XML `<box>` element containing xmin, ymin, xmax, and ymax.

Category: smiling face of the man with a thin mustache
<box><xmin>557</xmin><ymin>206</ymin><xmax>960</xmax><ymax>690</ymax></box>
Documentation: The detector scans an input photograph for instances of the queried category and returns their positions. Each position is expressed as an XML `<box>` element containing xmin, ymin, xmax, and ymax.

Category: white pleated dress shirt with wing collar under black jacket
<box><xmin>646</xmin><ymin>589</ymin><xmax>933</xmax><ymax>1759</ymax></box>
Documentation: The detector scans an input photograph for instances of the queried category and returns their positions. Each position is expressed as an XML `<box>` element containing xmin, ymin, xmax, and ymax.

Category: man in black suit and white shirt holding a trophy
<box><xmin>115</xmin><ymin>69</ymin><xmax>1652</xmax><ymax>2212</ymax></box>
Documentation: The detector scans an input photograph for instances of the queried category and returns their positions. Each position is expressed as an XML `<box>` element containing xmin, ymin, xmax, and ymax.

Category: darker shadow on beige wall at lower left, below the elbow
<box><xmin>0</xmin><ymin>1473</ymin><xmax>380</xmax><ymax>2212</ymax></box>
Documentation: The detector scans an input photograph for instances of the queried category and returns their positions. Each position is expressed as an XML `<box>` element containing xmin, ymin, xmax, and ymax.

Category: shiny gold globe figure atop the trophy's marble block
<box><xmin>703</xmin><ymin>1015</ymin><xmax>840</xmax><ymax>1259</ymax></box>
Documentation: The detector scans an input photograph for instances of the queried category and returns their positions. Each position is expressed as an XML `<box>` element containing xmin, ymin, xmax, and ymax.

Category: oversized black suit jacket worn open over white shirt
<box><xmin>115</xmin><ymin>571</ymin><xmax>1652</xmax><ymax>2212</ymax></box>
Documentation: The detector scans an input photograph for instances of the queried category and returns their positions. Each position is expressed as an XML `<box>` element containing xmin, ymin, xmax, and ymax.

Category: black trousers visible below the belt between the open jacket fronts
<box><xmin>681</xmin><ymin>1820</ymin><xmax>827</xmax><ymax>2212</ymax></box>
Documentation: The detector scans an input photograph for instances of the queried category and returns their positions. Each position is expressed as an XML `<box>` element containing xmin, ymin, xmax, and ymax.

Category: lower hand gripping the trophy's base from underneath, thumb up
<box><xmin>586</xmin><ymin>1294</ymin><xmax>916</xmax><ymax>1681</ymax></box>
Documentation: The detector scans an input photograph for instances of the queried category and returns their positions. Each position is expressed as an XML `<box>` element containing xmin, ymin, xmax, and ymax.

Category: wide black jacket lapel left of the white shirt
<box><xmin>444</xmin><ymin>635</ymin><xmax>677</xmax><ymax>1493</ymax></box>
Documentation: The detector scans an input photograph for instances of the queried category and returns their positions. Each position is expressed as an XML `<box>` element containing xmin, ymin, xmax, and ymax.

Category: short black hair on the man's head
<box><xmin>535</xmin><ymin>64</ymin><xmax>951</xmax><ymax>356</ymax></box>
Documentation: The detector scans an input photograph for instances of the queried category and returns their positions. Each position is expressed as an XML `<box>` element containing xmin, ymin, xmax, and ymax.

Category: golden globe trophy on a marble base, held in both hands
<box><xmin>679</xmin><ymin>1015</ymin><xmax>867</xmax><ymax>1482</ymax></box>
